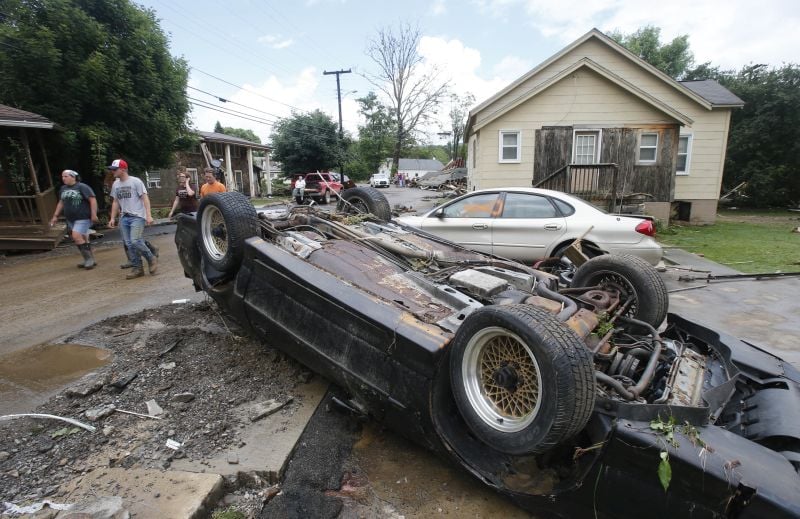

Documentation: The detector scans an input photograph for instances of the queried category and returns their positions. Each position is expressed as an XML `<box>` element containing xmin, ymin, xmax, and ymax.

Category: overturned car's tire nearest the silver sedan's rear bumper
<box><xmin>571</xmin><ymin>254</ymin><xmax>669</xmax><ymax>328</ymax></box>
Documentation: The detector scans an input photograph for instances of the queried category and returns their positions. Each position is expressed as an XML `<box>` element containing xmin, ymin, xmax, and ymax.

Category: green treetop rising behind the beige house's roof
<box><xmin>608</xmin><ymin>25</ymin><xmax>694</xmax><ymax>79</ymax></box>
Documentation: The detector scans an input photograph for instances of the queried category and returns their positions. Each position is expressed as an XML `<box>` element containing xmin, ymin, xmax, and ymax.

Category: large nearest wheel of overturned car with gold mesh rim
<box><xmin>449</xmin><ymin>305</ymin><xmax>595</xmax><ymax>455</ymax></box>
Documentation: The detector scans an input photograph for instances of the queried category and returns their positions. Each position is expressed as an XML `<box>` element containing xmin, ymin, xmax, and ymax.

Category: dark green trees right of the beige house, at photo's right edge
<box><xmin>720</xmin><ymin>64</ymin><xmax>800</xmax><ymax>207</ymax></box>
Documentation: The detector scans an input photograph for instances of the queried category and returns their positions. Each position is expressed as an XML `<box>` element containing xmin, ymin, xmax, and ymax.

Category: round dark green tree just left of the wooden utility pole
<box><xmin>272</xmin><ymin>110</ymin><xmax>346</xmax><ymax>174</ymax></box>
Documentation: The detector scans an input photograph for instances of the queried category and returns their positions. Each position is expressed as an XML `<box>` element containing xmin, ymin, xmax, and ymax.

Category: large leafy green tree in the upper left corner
<box><xmin>0</xmin><ymin>0</ymin><xmax>189</xmax><ymax>184</ymax></box>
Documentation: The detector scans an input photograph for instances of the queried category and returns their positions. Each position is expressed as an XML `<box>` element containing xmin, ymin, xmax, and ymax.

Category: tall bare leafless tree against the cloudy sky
<box><xmin>365</xmin><ymin>23</ymin><xmax>447</xmax><ymax>175</ymax></box>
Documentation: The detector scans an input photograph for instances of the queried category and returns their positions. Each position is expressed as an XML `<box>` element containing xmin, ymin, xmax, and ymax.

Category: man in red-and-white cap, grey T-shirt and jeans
<box><xmin>108</xmin><ymin>159</ymin><xmax>158</xmax><ymax>279</ymax></box>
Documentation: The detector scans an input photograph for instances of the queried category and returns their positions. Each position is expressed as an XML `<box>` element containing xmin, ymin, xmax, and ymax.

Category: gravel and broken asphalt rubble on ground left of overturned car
<box><xmin>0</xmin><ymin>302</ymin><xmax>312</xmax><ymax>517</ymax></box>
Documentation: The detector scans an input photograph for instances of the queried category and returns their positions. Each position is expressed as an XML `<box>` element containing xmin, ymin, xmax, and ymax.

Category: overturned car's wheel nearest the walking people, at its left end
<box><xmin>197</xmin><ymin>191</ymin><xmax>258</xmax><ymax>274</ymax></box>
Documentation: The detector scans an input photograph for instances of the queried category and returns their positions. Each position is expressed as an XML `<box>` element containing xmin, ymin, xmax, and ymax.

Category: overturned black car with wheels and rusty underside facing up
<box><xmin>175</xmin><ymin>192</ymin><xmax>800</xmax><ymax>518</ymax></box>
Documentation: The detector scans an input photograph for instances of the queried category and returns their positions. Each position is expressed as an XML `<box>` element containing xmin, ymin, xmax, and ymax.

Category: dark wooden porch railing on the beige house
<box><xmin>533</xmin><ymin>164</ymin><xmax>619</xmax><ymax>212</ymax></box>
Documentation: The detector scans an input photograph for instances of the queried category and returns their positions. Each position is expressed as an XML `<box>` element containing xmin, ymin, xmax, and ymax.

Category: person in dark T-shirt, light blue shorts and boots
<box><xmin>50</xmin><ymin>169</ymin><xmax>97</xmax><ymax>270</ymax></box>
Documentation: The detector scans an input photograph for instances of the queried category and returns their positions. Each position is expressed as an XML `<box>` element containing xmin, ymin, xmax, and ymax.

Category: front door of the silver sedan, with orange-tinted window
<box><xmin>412</xmin><ymin>193</ymin><xmax>499</xmax><ymax>254</ymax></box>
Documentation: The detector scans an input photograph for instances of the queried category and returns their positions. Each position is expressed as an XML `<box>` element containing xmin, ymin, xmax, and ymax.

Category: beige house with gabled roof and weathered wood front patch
<box><xmin>465</xmin><ymin>29</ymin><xmax>744</xmax><ymax>223</ymax></box>
